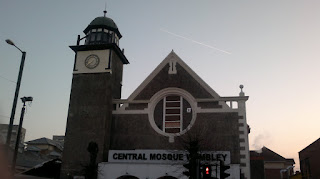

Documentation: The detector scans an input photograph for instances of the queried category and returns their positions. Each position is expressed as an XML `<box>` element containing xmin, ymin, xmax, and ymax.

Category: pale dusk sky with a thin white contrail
<box><xmin>0</xmin><ymin>0</ymin><xmax>320</xmax><ymax>170</ymax></box>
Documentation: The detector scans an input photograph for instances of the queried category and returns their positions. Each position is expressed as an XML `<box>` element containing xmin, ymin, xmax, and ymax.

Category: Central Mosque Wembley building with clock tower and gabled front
<box><xmin>61</xmin><ymin>11</ymin><xmax>250</xmax><ymax>179</ymax></box>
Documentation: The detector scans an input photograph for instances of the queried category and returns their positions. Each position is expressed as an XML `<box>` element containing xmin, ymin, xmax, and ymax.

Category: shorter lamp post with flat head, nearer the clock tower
<box><xmin>11</xmin><ymin>96</ymin><xmax>33</xmax><ymax>175</ymax></box>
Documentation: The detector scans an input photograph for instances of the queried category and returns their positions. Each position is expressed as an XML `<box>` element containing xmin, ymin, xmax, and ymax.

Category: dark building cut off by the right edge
<box><xmin>299</xmin><ymin>138</ymin><xmax>320</xmax><ymax>179</ymax></box>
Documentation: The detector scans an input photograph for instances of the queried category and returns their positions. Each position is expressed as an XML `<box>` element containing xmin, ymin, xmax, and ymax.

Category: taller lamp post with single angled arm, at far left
<box><xmin>6</xmin><ymin>39</ymin><xmax>26</xmax><ymax>149</ymax></box>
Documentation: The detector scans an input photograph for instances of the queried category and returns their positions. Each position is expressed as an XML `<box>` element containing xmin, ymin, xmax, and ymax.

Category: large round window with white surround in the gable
<box><xmin>149</xmin><ymin>88</ymin><xmax>197</xmax><ymax>137</ymax></box>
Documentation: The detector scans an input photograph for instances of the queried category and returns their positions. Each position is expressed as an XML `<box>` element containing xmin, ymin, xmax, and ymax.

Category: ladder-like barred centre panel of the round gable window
<box><xmin>162</xmin><ymin>96</ymin><xmax>183</xmax><ymax>133</ymax></box>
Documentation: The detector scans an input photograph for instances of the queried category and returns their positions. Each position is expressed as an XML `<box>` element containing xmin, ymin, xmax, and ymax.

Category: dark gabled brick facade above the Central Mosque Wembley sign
<box><xmin>110</xmin><ymin>52</ymin><xmax>250</xmax><ymax>178</ymax></box>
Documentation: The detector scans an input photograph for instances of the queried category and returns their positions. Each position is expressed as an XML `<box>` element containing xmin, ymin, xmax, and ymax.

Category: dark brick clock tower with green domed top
<box><xmin>61</xmin><ymin>11</ymin><xmax>129</xmax><ymax>178</ymax></box>
